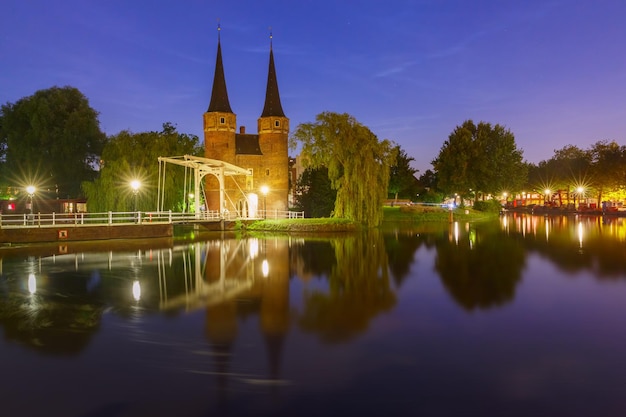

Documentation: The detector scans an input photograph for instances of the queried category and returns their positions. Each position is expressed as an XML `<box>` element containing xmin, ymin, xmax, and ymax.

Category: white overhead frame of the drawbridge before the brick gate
<box><xmin>157</xmin><ymin>155</ymin><xmax>252</xmax><ymax>217</ymax></box>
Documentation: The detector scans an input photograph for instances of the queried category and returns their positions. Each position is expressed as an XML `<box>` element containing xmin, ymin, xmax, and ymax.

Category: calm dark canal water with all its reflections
<box><xmin>0</xmin><ymin>215</ymin><xmax>626</xmax><ymax>417</ymax></box>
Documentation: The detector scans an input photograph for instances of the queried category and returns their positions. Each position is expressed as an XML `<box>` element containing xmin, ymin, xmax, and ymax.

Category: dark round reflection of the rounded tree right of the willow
<box><xmin>435</xmin><ymin>225</ymin><xmax>525</xmax><ymax>310</ymax></box>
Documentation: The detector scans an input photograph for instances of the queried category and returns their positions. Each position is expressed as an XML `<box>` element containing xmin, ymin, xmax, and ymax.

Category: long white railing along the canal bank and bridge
<box><xmin>0</xmin><ymin>210</ymin><xmax>304</xmax><ymax>228</ymax></box>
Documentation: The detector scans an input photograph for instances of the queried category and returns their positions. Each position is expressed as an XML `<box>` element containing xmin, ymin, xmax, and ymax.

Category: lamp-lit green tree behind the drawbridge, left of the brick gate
<box><xmin>83</xmin><ymin>123</ymin><xmax>203</xmax><ymax>212</ymax></box>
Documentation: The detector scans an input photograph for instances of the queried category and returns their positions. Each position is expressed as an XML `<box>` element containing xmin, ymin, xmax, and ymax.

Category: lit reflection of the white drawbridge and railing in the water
<box><xmin>17</xmin><ymin>238</ymin><xmax>270</xmax><ymax>311</ymax></box>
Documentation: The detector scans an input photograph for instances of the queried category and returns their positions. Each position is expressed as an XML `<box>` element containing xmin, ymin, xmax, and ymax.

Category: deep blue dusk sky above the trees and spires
<box><xmin>0</xmin><ymin>0</ymin><xmax>626</xmax><ymax>172</ymax></box>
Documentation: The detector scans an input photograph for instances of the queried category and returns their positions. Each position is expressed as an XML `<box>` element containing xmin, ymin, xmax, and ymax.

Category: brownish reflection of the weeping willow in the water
<box><xmin>299</xmin><ymin>230</ymin><xmax>396</xmax><ymax>343</ymax></box>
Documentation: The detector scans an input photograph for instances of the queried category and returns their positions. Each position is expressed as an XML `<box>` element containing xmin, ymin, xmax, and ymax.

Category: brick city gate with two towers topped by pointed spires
<box><xmin>204</xmin><ymin>29</ymin><xmax>290</xmax><ymax>212</ymax></box>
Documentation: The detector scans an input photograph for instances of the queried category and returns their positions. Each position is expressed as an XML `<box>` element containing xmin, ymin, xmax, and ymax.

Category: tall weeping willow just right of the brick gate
<box><xmin>291</xmin><ymin>112</ymin><xmax>397</xmax><ymax>227</ymax></box>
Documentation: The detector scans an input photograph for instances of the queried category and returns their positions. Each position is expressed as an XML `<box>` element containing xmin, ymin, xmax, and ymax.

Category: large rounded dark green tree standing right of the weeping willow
<box><xmin>432</xmin><ymin>120</ymin><xmax>527</xmax><ymax>196</ymax></box>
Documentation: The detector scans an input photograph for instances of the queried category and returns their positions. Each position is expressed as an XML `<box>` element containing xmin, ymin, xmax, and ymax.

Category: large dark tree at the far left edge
<box><xmin>0</xmin><ymin>86</ymin><xmax>106</xmax><ymax>197</ymax></box>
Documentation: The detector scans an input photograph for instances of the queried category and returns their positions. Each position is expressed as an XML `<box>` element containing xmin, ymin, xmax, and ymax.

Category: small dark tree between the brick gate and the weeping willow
<box><xmin>295</xmin><ymin>168</ymin><xmax>337</xmax><ymax>217</ymax></box>
